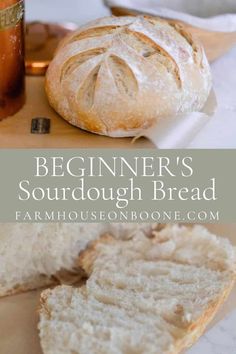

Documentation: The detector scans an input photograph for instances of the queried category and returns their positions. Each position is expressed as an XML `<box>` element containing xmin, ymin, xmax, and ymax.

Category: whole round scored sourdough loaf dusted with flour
<box><xmin>46</xmin><ymin>16</ymin><xmax>211</xmax><ymax>137</ymax></box>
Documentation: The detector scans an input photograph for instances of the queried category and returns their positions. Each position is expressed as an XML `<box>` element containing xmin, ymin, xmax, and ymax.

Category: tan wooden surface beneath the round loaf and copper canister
<box><xmin>0</xmin><ymin>76</ymin><xmax>154</xmax><ymax>148</ymax></box>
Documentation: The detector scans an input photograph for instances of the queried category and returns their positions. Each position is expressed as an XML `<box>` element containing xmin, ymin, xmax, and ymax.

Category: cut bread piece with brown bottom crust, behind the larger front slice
<box><xmin>0</xmin><ymin>223</ymin><xmax>155</xmax><ymax>296</ymax></box>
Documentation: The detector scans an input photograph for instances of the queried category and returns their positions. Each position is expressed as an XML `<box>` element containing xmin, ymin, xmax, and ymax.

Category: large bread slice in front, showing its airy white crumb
<box><xmin>39</xmin><ymin>225</ymin><xmax>235</xmax><ymax>354</ymax></box>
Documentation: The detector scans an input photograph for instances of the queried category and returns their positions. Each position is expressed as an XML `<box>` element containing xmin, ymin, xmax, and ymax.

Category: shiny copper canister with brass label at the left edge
<box><xmin>0</xmin><ymin>0</ymin><xmax>25</xmax><ymax>120</ymax></box>
